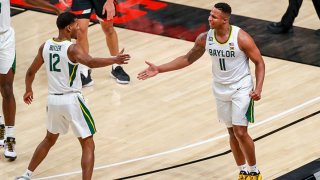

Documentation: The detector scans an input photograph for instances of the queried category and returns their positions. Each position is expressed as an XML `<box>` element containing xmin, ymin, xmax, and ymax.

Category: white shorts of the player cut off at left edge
<box><xmin>0</xmin><ymin>28</ymin><xmax>16</xmax><ymax>74</ymax></box>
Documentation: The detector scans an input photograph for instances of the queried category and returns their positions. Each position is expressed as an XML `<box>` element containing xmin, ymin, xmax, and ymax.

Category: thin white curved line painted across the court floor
<box><xmin>34</xmin><ymin>97</ymin><xmax>320</xmax><ymax>180</ymax></box>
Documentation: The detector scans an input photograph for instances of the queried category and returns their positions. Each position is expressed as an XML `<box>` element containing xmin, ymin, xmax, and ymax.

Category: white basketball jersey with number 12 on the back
<box><xmin>42</xmin><ymin>39</ymin><xmax>82</xmax><ymax>94</ymax></box>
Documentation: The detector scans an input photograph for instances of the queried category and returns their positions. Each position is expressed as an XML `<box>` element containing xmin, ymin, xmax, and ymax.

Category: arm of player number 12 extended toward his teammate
<box><xmin>68</xmin><ymin>44</ymin><xmax>130</xmax><ymax>68</ymax></box>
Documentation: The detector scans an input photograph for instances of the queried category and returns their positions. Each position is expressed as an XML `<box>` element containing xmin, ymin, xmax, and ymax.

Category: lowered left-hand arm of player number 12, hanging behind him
<box><xmin>23</xmin><ymin>44</ymin><xmax>44</xmax><ymax>104</ymax></box>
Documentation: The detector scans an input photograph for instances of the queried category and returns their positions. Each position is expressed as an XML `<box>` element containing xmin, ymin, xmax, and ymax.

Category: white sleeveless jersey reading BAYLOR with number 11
<box><xmin>206</xmin><ymin>26</ymin><xmax>250</xmax><ymax>84</ymax></box>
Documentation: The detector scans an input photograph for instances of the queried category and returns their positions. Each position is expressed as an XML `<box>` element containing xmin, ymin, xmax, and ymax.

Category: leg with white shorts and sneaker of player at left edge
<box><xmin>0</xmin><ymin>28</ymin><xmax>17</xmax><ymax>161</ymax></box>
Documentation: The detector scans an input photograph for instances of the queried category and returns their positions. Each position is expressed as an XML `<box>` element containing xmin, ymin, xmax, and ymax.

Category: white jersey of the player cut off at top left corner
<box><xmin>0</xmin><ymin>0</ymin><xmax>10</xmax><ymax>34</ymax></box>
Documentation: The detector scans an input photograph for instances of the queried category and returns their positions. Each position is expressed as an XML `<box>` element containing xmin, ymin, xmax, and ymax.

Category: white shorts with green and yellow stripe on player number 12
<box><xmin>46</xmin><ymin>93</ymin><xmax>96</xmax><ymax>138</ymax></box>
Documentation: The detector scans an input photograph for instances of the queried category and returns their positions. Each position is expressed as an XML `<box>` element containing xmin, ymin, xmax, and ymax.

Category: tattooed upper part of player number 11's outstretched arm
<box><xmin>186</xmin><ymin>33</ymin><xmax>207</xmax><ymax>64</ymax></box>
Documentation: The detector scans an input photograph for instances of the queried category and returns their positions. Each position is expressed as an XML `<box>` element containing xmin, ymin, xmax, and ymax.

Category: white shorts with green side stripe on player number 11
<box><xmin>213</xmin><ymin>75</ymin><xmax>254</xmax><ymax>128</ymax></box>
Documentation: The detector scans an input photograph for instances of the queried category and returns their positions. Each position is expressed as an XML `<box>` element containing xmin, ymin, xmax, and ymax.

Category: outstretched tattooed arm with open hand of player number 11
<box><xmin>137</xmin><ymin>33</ymin><xmax>207</xmax><ymax>80</ymax></box>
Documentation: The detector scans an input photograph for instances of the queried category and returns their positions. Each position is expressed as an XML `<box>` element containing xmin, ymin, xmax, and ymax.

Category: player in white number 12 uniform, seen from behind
<box><xmin>17</xmin><ymin>12</ymin><xmax>130</xmax><ymax>180</ymax></box>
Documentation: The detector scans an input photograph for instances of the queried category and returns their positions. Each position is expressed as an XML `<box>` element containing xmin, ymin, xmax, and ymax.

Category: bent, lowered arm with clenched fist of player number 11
<box><xmin>238</xmin><ymin>30</ymin><xmax>265</xmax><ymax>101</ymax></box>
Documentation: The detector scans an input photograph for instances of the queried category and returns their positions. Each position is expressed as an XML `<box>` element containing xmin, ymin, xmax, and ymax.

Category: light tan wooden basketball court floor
<box><xmin>0</xmin><ymin>0</ymin><xmax>320</xmax><ymax>180</ymax></box>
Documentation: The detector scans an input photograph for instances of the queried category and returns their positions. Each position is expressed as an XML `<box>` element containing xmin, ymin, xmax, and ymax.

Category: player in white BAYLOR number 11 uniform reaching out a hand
<box><xmin>138</xmin><ymin>3</ymin><xmax>265</xmax><ymax>180</ymax></box>
